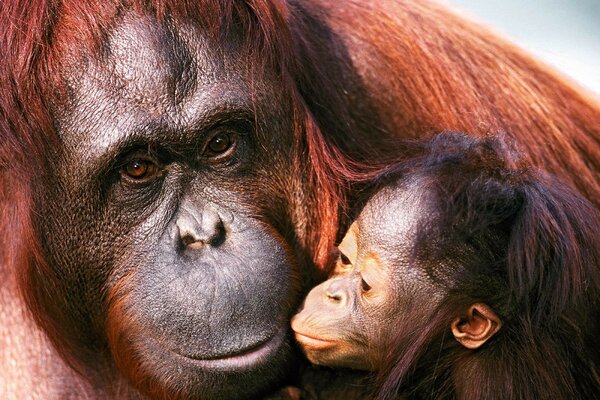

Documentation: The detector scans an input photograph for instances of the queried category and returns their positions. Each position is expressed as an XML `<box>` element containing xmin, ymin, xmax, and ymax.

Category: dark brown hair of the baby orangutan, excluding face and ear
<box><xmin>377</xmin><ymin>133</ymin><xmax>600</xmax><ymax>399</ymax></box>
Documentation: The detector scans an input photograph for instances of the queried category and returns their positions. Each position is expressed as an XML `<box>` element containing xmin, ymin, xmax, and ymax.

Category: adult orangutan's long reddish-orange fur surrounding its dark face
<box><xmin>0</xmin><ymin>0</ymin><xmax>600</xmax><ymax>397</ymax></box>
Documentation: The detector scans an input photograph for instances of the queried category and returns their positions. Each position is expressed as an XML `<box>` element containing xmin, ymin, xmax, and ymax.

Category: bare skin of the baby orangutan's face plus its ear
<box><xmin>292</xmin><ymin>181</ymin><xmax>500</xmax><ymax>370</ymax></box>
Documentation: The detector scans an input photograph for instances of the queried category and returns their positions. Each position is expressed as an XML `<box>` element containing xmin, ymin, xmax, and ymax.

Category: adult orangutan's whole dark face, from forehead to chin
<box><xmin>38</xmin><ymin>15</ymin><xmax>296</xmax><ymax>399</ymax></box>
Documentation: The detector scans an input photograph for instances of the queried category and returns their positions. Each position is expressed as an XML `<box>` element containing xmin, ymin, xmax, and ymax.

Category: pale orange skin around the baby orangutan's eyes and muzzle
<box><xmin>292</xmin><ymin>222</ymin><xmax>390</xmax><ymax>369</ymax></box>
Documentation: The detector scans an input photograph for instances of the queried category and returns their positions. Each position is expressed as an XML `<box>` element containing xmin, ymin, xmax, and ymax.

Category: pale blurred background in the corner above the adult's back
<box><xmin>442</xmin><ymin>0</ymin><xmax>600</xmax><ymax>94</ymax></box>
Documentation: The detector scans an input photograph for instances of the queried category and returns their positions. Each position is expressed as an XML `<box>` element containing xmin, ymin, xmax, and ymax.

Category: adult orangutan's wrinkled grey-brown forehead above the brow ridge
<box><xmin>56</xmin><ymin>12</ymin><xmax>266</xmax><ymax>170</ymax></box>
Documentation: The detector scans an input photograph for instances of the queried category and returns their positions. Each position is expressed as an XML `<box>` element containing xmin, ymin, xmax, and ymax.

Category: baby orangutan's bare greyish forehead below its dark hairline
<box><xmin>356</xmin><ymin>181</ymin><xmax>431</xmax><ymax>248</ymax></box>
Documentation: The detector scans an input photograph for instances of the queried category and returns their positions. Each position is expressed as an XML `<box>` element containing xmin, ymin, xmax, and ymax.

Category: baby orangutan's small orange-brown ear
<box><xmin>450</xmin><ymin>303</ymin><xmax>502</xmax><ymax>349</ymax></box>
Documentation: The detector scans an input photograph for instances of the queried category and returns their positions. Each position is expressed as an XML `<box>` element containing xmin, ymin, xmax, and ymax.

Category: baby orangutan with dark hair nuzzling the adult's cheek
<box><xmin>292</xmin><ymin>133</ymin><xmax>600</xmax><ymax>399</ymax></box>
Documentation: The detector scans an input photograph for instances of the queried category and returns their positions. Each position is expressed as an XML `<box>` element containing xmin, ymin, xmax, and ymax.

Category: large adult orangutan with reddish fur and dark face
<box><xmin>0</xmin><ymin>0</ymin><xmax>600</xmax><ymax>399</ymax></box>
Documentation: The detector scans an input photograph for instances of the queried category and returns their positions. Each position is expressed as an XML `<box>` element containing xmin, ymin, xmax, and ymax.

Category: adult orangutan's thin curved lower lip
<box><xmin>168</xmin><ymin>329</ymin><xmax>285</xmax><ymax>371</ymax></box>
